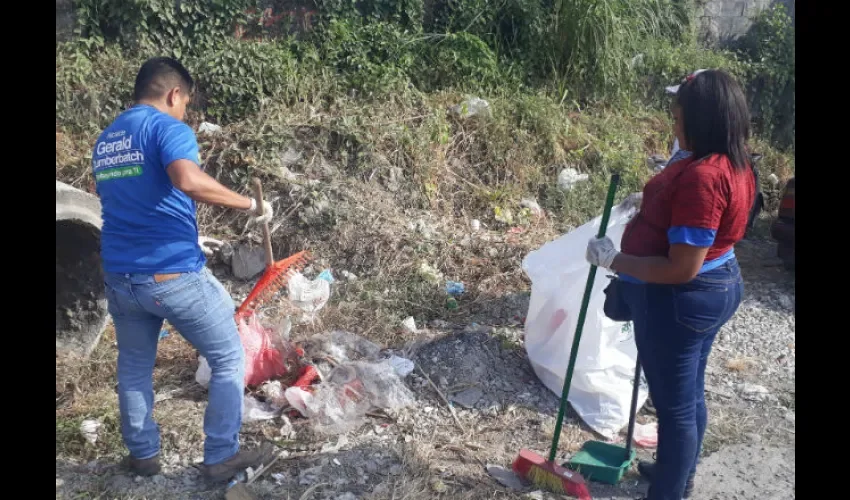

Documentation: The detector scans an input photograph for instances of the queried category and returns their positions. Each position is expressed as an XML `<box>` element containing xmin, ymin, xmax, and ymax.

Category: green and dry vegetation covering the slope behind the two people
<box><xmin>56</xmin><ymin>0</ymin><xmax>794</xmax><ymax>234</ymax></box>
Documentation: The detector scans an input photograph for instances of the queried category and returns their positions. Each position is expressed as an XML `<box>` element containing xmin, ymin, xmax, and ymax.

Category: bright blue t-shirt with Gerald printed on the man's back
<box><xmin>92</xmin><ymin>105</ymin><xmax>206</xmax><ymax>274</ymax></box>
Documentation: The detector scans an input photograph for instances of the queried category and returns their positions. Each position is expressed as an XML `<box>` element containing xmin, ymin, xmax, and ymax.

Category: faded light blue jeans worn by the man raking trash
<box><xmin>105</xmin><ymin>268</ymin><xmax>245</xmax><ymax>465</ymax></box>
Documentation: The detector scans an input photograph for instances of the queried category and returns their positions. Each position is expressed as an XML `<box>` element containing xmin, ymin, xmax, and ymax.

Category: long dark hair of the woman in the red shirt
<box><xmin>675</xmin><ymin>70</ymin><xmax>750</xmax><ymax>169</ymax></box>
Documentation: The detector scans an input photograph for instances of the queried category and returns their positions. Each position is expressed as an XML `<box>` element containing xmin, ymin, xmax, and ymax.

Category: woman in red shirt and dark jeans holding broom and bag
<box><xmin>587</xmin><ymin>70</ymin><xmax>755</xmax><ymax>500</ymax></box>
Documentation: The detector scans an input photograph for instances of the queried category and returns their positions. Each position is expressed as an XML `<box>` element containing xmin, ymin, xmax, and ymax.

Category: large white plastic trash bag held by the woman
<box><xmin>522</xmin><ymin>201</ymin><xmax>647</xmax><ymax>439</ymax></box>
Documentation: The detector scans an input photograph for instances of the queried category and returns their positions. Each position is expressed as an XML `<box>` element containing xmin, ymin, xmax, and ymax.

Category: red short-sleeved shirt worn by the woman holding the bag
<box><xmin>621</xmin><ymin>155</ymin><xmax>755</xmax><ymax>261</ymax></box>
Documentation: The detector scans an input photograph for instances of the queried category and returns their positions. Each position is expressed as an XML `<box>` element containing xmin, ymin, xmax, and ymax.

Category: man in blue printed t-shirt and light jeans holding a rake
<box><xmin>92</xmin><ymin>57</ymin><xmax>272</xmax><ymax>481</ymax></box>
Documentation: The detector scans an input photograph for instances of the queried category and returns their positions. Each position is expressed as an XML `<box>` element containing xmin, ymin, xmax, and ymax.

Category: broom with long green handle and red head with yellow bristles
<box><xmin>513</xmin><ymin>174</ymin><xmax>620</xmax><ymax>500</ymax></box>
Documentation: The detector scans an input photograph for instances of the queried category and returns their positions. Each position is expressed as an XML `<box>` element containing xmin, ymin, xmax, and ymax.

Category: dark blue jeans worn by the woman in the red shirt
<box><xmin>623</xmin><ymin>259</ymin><xmax>744</xmax><ymax>500</ymax></box>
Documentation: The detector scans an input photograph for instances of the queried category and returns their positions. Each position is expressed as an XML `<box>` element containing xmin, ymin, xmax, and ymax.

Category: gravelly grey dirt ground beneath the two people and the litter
<box><xmin>56</xmin><ymin>235</ymin><xmax>795</xmax><ymax>500</ymax></box>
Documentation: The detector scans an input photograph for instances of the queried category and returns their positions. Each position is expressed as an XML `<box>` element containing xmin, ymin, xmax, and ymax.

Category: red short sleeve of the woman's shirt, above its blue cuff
<box><xmin>670</xmin><ymin>163</ymin><xmax>728</xmax><ymax>232</ymax></box>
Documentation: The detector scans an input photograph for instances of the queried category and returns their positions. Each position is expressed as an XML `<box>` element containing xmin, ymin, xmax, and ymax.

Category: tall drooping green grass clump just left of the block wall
<box><xmin>549</xmin><ymin>0</ymin><xmax>687</xmax><ymax>97</ymax></box>
